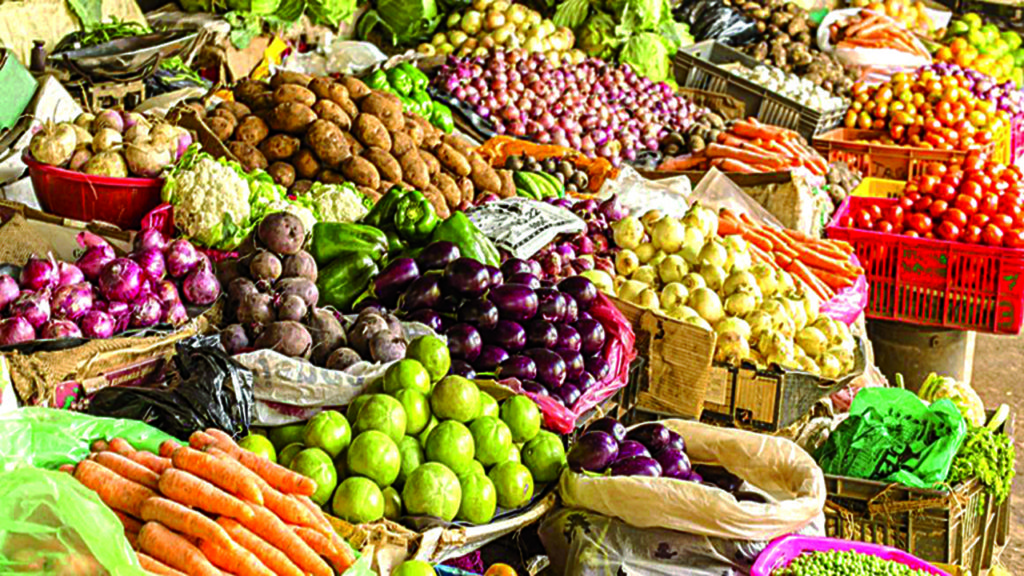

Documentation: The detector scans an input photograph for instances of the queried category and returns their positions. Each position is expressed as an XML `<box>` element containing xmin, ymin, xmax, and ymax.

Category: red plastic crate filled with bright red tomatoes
<box><xmin>825</xmin><ymin>196</ymin><xmax>1024</xmax><ymax>334</ymax></box>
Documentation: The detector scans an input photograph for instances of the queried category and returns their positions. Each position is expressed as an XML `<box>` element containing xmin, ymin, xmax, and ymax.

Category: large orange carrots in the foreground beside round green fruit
<box><xmin>61</xmin><ymin>428</ymin><xmax>354</xmax><ymax>576</ymax></box>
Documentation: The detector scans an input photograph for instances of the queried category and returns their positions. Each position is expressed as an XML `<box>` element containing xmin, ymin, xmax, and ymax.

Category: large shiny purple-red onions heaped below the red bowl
<box><xmin>0</xmin><ymin>229</ymin><xmax>220</xmax><ymax>345</ymax></box>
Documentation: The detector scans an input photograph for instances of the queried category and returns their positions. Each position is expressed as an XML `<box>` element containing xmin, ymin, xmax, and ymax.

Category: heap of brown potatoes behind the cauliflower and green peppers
<box><xmin>192</xmin><ymin>71</ymin><xmax>507</xmax><ymax>217</ymax></box>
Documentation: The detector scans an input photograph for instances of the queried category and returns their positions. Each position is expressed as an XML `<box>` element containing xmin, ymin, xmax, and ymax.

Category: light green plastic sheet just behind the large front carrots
<box><xmin>0</xmin><ymin>407</ymin><xmax>174</xmax><ymax>470</ymax></box>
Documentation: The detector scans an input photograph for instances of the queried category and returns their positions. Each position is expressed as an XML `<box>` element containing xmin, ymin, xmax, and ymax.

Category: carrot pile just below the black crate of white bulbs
<box><xmin>657</xmin><ymin>118</ymin><xmax>828</xmax><ymax>176</ymax></box>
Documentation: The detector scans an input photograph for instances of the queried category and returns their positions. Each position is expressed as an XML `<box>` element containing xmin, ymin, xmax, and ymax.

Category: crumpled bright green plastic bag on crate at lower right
<box><xmin>814</xmin><ymin>388</ymin><xmax>967</xmax><ymax>489</ymax></box>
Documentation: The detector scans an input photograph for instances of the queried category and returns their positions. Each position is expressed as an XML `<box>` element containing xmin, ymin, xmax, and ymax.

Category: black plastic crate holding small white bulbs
<box><xmin>673</xmin><ymin>40</ymin><xmax>846</xmax><ymax>140</ymax></box>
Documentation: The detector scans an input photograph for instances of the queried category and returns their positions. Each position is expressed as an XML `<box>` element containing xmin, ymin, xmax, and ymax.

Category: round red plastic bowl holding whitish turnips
<box><xmin>22</xmin><ymin>154</ymin><xmax>164</xmax><ymax>230</ymax></box>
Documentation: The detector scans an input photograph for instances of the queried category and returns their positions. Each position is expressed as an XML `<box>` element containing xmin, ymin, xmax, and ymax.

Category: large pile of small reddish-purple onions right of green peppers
<box><xmin>434</xmin><ymin>49</ymin><xmax>698</xmax><ymax>165</ymax></box>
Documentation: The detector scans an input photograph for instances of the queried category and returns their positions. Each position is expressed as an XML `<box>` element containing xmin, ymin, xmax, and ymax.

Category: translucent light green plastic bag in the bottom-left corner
<box><xmin>0</xmin><ymin>466</ymin><xmax>146</xmax><ymax>576</ymax></box>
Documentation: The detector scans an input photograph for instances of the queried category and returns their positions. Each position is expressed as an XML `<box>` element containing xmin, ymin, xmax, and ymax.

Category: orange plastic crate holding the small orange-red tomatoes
<box><xmin>813</xmin><ymin>128</ymin><xmax>995</xmax><ymax>180</ymax></box>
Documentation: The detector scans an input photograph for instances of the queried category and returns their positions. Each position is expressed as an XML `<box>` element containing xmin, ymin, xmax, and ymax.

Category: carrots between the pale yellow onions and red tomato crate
<box><xmin>718</xmin><ymin>208</ymin><xmax>864</xmax><ymax>301</ymax></box>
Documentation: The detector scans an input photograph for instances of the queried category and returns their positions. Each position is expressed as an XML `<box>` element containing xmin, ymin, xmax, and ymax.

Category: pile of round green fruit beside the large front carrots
<box><xmin>246</xmin><ymin>336</ymin><xmax>565</xmax><ymax>524</ymax></box>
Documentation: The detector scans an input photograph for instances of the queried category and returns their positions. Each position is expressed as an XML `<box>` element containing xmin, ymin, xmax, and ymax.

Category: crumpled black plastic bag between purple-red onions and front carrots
<box><xmin>87</xmin><ymin>335</ymin><xmax>255</xmax><ymax>441</ymax></box>
